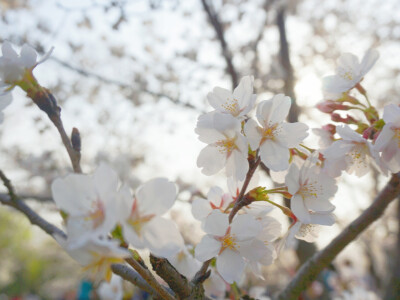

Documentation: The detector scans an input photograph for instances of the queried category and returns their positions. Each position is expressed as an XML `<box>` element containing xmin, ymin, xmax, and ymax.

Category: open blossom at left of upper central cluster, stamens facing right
<box><xmin>196</xmin><ymin>113</ymin><xmax>249</xmax><ymax>180</ymax></box>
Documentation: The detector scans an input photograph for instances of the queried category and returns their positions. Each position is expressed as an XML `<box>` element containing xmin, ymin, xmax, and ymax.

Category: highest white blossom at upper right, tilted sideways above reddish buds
<box><xmin>323</xmin><ymin>49</ymin><xmax>379</xmax><ymax>100</ymax></box>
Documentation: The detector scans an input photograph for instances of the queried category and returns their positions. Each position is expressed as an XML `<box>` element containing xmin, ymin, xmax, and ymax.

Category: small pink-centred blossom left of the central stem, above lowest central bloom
<box><xmin>192</xmin><ymin>186</ymin><xmax>234</xmax><ymax>221</ymax></box>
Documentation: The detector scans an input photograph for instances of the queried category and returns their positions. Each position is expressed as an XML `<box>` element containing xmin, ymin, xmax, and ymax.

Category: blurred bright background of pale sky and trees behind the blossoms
<box><xmin>0</xmin><ymin>0</ymin><xmax>400</xmax><ymax>299</ymax></box>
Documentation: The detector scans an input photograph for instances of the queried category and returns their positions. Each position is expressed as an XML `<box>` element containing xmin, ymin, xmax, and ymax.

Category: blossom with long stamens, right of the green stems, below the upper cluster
<box><xmin>285</xmin><ymin>152</ymin><xmax>337</xmax><ymax>224</ymax></box>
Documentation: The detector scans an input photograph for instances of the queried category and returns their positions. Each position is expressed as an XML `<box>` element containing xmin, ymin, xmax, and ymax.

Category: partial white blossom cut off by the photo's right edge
<box><xmin>374</xmin><ymin>104</ymin><xmax>400</xmax><ymax>173</ymax></box>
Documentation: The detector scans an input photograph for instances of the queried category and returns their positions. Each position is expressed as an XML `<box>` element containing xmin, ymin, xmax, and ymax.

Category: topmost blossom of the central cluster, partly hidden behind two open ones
<box><xmin>207</xmin><ymin>76</ymin><xmax>256</xmax><ymax>118</ymax></box>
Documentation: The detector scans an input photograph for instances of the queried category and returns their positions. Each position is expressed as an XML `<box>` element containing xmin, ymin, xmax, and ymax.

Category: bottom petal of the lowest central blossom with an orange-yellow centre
<box><xmin>217</xmin><ymin>249</ymin><xmax>246</xmax><ymax>283</ymax></box>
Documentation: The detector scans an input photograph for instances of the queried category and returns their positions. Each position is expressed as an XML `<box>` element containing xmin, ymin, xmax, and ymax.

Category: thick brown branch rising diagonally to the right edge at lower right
<box><xmin>277</xmin><ymin>173</ymin><xmax>400</xmax><ymax>300</ymax></box>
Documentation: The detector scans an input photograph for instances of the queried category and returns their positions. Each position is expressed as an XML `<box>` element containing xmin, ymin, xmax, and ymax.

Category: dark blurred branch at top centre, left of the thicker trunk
<box><xmin>201</xmin><ymin>0</ymin><xmax>239</xmax><ymax>89</ymax></box>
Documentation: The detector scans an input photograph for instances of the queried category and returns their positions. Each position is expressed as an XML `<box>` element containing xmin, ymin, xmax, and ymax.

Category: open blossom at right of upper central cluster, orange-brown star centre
<box><xmin>244</xmin><ymin>94</ymin><xmax>308</xmax><ymax>171</ymax></box>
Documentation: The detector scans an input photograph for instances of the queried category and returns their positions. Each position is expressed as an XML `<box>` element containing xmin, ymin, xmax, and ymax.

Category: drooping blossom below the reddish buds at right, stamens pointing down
<box><xmin>322</xmin><ymin>125</ymin><xmax>387</xmax><ymax>177</ymax></box>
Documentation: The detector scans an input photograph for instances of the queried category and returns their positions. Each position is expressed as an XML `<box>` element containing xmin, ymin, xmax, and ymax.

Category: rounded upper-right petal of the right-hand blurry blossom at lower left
<box><xmin>136</xmin><ymin>178</ymin><xmax>176</xmax><ymax>215</ymax></box>
